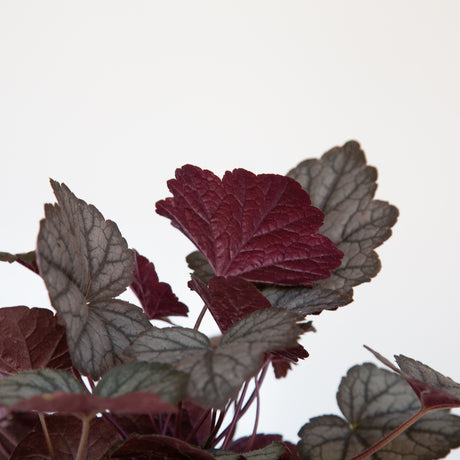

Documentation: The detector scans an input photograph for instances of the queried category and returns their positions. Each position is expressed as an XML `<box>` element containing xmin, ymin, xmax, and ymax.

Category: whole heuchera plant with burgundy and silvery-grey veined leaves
<box><xmin>0</xmin><ymin>142</ymin><xmax>460</xmax><ymax>460</ymax></box>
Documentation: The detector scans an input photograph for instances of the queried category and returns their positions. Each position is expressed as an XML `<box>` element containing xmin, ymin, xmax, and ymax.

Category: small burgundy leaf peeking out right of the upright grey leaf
<box><xmin>131</xmin><ymin>251</ymin><xmax>188</xmax><ymax>319</ymax></box>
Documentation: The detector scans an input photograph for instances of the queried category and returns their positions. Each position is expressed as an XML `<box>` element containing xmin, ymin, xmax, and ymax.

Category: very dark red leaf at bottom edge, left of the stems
<box><xmin>111</xmin><ymin>434</ymin><xmax>214</xmax><ymax>460</ymax></box>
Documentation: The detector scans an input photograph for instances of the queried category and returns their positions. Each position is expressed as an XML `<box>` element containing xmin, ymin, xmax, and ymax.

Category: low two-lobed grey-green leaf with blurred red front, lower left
<box><xmin>0</xmin><ymin>363</ymin><xmax>188</xmax><ymax>414</ymax></box>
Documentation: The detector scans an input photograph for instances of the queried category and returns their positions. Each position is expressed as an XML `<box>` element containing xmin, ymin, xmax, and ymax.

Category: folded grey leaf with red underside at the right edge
<box><xmin>365</xmin><ymin>347</ymin><xmax>460</xmax><ymax>410</ymax></box>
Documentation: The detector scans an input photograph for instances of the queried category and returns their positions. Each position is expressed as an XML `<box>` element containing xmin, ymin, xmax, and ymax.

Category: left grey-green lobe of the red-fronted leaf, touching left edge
<box><xmin>0</xmin><ymin>368</ymin><xmax>85</xmax><ymax>407</ymax></box>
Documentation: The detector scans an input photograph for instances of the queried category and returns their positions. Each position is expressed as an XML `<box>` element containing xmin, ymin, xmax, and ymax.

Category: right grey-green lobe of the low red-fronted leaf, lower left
<box><xmin>94</xmin><ymin>362</ymin><xmax>188</xmax><ymax>404</ymax></box>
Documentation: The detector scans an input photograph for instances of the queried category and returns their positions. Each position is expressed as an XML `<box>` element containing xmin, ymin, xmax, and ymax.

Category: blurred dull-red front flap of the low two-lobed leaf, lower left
<box><xmin>9</xmin><ymin>392</ymin><xmax>177</xmax><ymax>414</ymax></box>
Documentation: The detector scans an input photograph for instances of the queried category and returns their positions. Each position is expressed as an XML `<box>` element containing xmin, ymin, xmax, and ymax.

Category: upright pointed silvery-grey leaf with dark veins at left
<box><xmin>38</xmin><ymin>181</ymin><xmax>151</xmax><ymax>379</ymax></box>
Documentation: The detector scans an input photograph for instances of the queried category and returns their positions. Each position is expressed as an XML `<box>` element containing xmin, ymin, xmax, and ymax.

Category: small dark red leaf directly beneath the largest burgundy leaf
<box><xmin>190</xmin><ymin>276</ymin><xmax>271</xmax><ymax>332</ymax></box>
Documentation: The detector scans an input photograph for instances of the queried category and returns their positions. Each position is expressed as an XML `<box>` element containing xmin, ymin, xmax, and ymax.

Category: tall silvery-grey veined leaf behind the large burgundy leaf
<box><xmin>264</xmin><ymin>141</ymin><xmax>398</xmax><ymax>314</ymax></box>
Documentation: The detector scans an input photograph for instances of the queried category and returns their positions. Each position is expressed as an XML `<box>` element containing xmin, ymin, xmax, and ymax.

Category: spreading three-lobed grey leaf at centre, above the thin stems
<box><xmin>126</xmin><ymin>308</ymin><xmax>303</xmax><ymax>408</ymax></box>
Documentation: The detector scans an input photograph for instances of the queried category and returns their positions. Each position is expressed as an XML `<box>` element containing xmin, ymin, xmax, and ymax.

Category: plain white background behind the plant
<box><xmin>0</xmin><ymin>0</ymin><xmax>460</xmax><ymax>458</ymax></box>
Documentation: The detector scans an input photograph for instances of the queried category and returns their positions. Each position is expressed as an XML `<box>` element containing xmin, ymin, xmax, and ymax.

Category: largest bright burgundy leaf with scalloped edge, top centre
<box><xmin>157</xmin><ymin>165</ymin><xmax>343</xmax><ymax>286</ymax></box>
